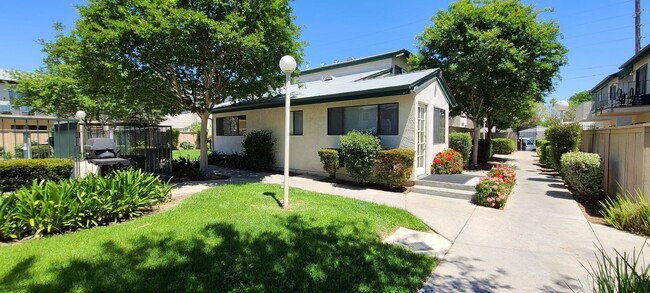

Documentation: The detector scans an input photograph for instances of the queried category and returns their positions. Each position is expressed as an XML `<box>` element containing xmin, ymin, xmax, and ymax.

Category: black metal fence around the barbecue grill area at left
<box><xmin>0</xmin><ymin>115</ymin><xmax>172</xmax><ymax>177</ymax></box>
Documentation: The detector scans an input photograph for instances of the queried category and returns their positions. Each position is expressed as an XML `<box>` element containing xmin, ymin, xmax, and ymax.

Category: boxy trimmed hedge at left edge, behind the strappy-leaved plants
<box><xmin>0</xmin><ymin>159</ymin><xmax>74</xmax><ymax>191</ymax></box>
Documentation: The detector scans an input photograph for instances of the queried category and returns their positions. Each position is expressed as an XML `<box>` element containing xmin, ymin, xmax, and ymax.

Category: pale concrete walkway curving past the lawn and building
<box><xmin>173</xmin><ymin>152</ymin><xmax>645</xmax><ymax>292</ymax></box>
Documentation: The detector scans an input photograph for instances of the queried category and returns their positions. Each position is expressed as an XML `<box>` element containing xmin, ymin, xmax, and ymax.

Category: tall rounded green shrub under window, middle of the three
<box><xmin>341</xmin><ymin>130</ymin><xmax>381</xmax><ymax>182</ymax></box>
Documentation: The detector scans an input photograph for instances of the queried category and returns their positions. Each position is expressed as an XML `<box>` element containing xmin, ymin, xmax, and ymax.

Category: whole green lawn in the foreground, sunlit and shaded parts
<box><xmin>0</xmin><ymin>184</ymin><xmax>437</xmax><ymax>292</ymax></box>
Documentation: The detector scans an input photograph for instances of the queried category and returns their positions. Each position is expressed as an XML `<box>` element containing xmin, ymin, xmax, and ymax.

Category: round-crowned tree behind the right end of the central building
<box><xmin>409</xmin><ymin>0</ymin><xmax>567</xmax><ymax>164</ymax></box>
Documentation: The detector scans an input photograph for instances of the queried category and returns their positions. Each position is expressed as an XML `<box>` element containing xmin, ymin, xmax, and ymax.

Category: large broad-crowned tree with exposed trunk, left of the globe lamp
<box><xmin>58</xmin><ymin>0</ymin><xmax>303</xmax><ymax>171</ymax></box>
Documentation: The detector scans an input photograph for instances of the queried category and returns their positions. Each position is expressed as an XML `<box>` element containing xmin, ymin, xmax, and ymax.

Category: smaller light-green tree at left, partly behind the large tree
<box><xmin>11</xmin><ymin>24</ymin><xmax>168</xmax><ymax>123</ymax></box>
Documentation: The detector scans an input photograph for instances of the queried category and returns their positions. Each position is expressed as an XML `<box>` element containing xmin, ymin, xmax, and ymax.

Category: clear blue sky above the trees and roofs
<box><xmin>0</xmin><ymin>0</ymin><xmax>650</xmax><ymax>100</ymax></box>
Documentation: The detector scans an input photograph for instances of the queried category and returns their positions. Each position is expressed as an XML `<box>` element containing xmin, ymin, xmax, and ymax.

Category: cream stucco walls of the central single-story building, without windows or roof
<box><xmin>212</xmin><ymin>82</ymin><xmax>449</xmax><ymax>180</ymax></box>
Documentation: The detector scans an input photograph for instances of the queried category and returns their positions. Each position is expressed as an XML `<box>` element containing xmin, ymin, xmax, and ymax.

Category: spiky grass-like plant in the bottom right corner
<box><xmin>585</xmin><ymin>242</ymin><xmax>650</xmax><ymax>293</ymax></box>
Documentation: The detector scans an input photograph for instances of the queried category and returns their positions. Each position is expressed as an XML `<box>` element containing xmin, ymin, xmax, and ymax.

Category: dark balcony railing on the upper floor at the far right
<box><xmin>592</xmin><ymin>80</ymin><xmax>650</xmax><ymax>111</ymax></box>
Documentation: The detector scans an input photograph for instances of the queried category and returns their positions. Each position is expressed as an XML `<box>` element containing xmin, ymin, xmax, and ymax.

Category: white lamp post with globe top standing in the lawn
<box><xmin>280</xmin><ymin>55</ymin><xmax>296</xmax><ymax>209</ymax></box>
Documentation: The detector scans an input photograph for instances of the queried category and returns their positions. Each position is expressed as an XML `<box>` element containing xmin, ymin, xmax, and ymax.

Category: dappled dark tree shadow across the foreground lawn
<box><xmin>0</xmin><ymin>216</ymin><xmax>435</xmax><ymax>292</ymax></box>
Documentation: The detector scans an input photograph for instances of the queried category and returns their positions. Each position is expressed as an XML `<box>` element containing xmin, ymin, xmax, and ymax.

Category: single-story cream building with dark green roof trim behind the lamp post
<box><xmin>212</xmin><ymin>50</ymin><xmax>456</xmax><ymax>179</ymax></box>
